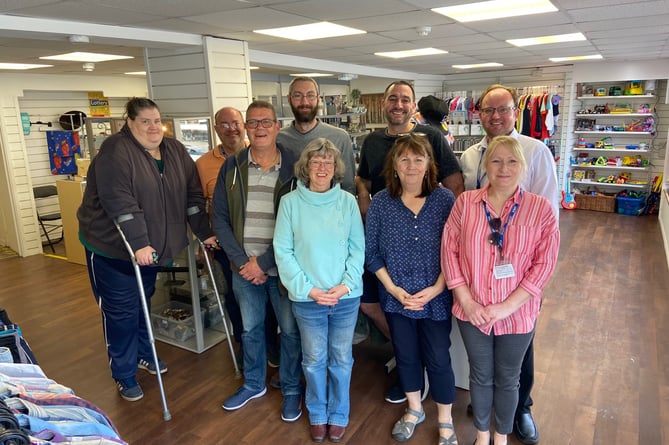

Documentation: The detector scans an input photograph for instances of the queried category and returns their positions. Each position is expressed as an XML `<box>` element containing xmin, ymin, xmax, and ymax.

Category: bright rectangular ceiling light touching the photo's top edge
<box><xmin>432</xmin><ymin>0</ymin><xmax>558</xmax><ymax>22</ymax></box>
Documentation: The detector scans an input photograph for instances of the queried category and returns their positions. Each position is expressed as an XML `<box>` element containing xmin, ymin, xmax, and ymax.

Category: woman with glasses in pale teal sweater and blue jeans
<box><xmin>274</xmin><ymin>138</ymin><xmax>365</xmax><ymax>442</ymax></box>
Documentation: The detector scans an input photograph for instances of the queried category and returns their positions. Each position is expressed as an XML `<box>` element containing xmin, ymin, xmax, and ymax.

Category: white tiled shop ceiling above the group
<box><xmin>0</xmin><ymin>0</ymin><xmax>669</xmax><ymax>75</ymax></box>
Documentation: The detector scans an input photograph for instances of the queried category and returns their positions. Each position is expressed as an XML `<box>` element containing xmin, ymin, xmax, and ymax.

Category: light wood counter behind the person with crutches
<box><xmin>56</xmin><ymin>180</ymin><xmax>86</xmax><ymax>266</ymax></box>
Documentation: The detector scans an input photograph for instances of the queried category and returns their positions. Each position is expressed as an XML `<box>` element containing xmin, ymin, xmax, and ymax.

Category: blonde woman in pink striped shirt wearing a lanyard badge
<box><xmin>441</xmin><ymin>136</ymin><xmax>560</xmax><ymax>445</ymax></box>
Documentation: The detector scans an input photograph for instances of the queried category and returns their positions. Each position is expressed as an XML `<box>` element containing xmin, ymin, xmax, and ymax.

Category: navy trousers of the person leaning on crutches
<box><xmin>86</xmin><ymin>250</ymin><xmax>159</xmax><ymax>380</ymax></box>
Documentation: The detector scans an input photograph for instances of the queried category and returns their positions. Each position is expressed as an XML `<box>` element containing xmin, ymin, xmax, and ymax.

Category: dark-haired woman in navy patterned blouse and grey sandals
<box><xmin>365</xmin><ymin>133</ymin><xmax>457</xmax><ymax>445</ymax></box>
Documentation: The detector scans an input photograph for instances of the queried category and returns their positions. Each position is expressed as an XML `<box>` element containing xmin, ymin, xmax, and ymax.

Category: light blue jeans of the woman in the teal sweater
<box><xmin>290</xmin><ymin>298</ymin><xmax>360</xmax><ymax>426</ymax></box>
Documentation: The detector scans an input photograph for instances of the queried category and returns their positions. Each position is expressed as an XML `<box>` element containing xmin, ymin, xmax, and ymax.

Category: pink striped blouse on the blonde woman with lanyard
<box><xmin>441</xmin><ymin>185</ymin><xmax>560</xmax><ymax>335</ymax></box>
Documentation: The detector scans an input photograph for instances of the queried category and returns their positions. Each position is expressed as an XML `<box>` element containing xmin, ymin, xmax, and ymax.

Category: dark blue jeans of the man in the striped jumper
<box><xmin>232</xmin><ymin>272</ymin><xmax>302</xmax><ymax>396</ymax></box>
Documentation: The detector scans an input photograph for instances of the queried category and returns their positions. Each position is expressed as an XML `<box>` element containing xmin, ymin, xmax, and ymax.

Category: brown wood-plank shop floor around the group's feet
<box><xmin>0</xmin><ymin>211</ymin><xmax>669</xmax><ymax>445</ymax></box>
